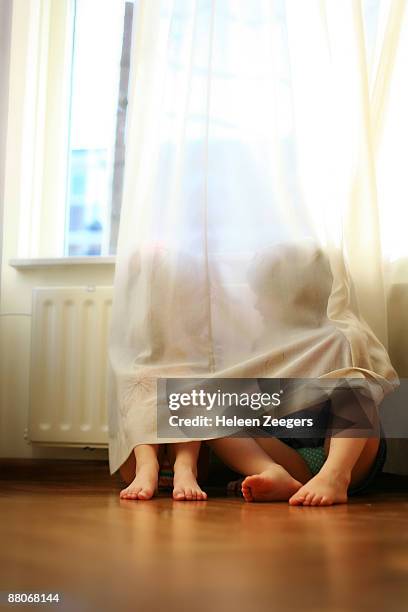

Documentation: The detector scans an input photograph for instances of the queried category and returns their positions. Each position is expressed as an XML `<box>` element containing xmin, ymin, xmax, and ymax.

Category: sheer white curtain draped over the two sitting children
<box><xmin>109</xmin><ymin>0</ymin><xmax>408</xmax><ymax>472</ymax></box>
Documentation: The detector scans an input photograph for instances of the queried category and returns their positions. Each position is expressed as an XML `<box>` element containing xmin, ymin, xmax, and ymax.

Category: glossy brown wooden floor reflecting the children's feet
<box><xmin>0</xmin><ymin>463</ymin><xmax>408</xmax><ymax>612</ymax></box>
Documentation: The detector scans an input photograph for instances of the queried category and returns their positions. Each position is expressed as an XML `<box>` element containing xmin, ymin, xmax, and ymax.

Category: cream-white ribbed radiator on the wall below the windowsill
<box><xmin>28</xmin><ymin>287</ymin><xmax>112</xmax><ymax>447</ymax></box>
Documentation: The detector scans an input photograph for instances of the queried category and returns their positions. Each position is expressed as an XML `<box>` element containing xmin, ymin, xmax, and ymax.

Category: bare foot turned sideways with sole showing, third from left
<box><xmin>242</xmin><ymin>464</ymin><xmax>302</xmax><ymax>502</ymax></box>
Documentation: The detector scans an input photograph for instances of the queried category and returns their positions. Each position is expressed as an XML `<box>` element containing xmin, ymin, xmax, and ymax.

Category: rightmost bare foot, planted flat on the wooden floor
<box><xmin>289</xmin><ymin>470</ymin><xmax>350</xmax><ymax>506</ymax></box>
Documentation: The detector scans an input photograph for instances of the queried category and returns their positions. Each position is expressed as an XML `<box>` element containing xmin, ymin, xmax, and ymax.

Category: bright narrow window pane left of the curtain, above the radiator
<box><xmin>64</xmin><ymin>0</ymin><xmax>133</xmax><ymax>256</ymax></box>
